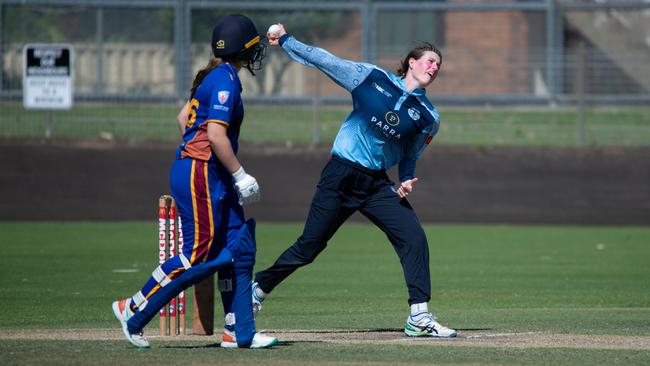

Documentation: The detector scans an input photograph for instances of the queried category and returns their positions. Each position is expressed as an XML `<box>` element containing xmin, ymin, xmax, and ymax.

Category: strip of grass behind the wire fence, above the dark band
<box><xmin>0</xmin><ymin>103</ymin><xmax>650</xmax><ymax>146</ymax></box>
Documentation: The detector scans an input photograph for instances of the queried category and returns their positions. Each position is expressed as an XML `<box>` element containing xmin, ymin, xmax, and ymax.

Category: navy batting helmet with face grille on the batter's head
<box><xmin>212</xmin><ymin>14</ymin><xmax>266</xmax><ymax>75</ymax></box>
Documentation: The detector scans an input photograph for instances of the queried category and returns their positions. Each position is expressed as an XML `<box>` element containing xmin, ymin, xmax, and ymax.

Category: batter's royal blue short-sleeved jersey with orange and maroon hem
<box><xmin>179</xmin><ymin>62</ymin><xmax>244</xmax><ymax>162</ymax></box>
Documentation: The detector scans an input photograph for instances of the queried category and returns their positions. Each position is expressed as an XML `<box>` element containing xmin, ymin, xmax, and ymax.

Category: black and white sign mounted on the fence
<box><xmin>23</xmin><ymin>44</ymin><xmax>73</xmax><ymax>109</ymax></box>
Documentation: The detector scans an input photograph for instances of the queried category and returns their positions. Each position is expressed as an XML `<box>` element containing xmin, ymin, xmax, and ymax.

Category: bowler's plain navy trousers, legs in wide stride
<box><xmin>255</xmin><ymin>156</ymin><xmax>431</xmax><ymax>304</ymax></box>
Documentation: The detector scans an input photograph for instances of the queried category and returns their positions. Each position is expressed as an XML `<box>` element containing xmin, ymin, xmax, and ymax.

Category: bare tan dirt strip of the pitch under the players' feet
<box><xmin>0</xmin><ymin>329</ymin><xmax>650</xmax><ymax>350</ymax></box>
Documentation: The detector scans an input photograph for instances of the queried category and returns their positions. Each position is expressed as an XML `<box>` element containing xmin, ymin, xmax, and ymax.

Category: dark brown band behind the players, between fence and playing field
<box><xmin>0</xmin><ymin>141</ymin><xmax>650</xmax><ymax>225</ymax></box>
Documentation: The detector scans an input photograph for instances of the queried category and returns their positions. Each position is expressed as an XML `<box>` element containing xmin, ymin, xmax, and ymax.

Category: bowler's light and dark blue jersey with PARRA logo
<box><xmin>280</xmin><ymin>35</ymin><xmax>440</xmax><ymax>182</ymax></box>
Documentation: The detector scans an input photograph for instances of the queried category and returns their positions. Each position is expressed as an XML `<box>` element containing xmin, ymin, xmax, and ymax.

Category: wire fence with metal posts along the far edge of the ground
<box><xmin>0</xmin><ymin>0</ymin><xmax>650</xmax><ymax>145</ymax></box>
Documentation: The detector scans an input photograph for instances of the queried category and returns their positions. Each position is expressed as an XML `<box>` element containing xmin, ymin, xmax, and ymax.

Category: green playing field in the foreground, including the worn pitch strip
<box><xmin>0</xmin><ymin>221</ymin><xmax>650</xmax><ymax>365</ymax></box>
